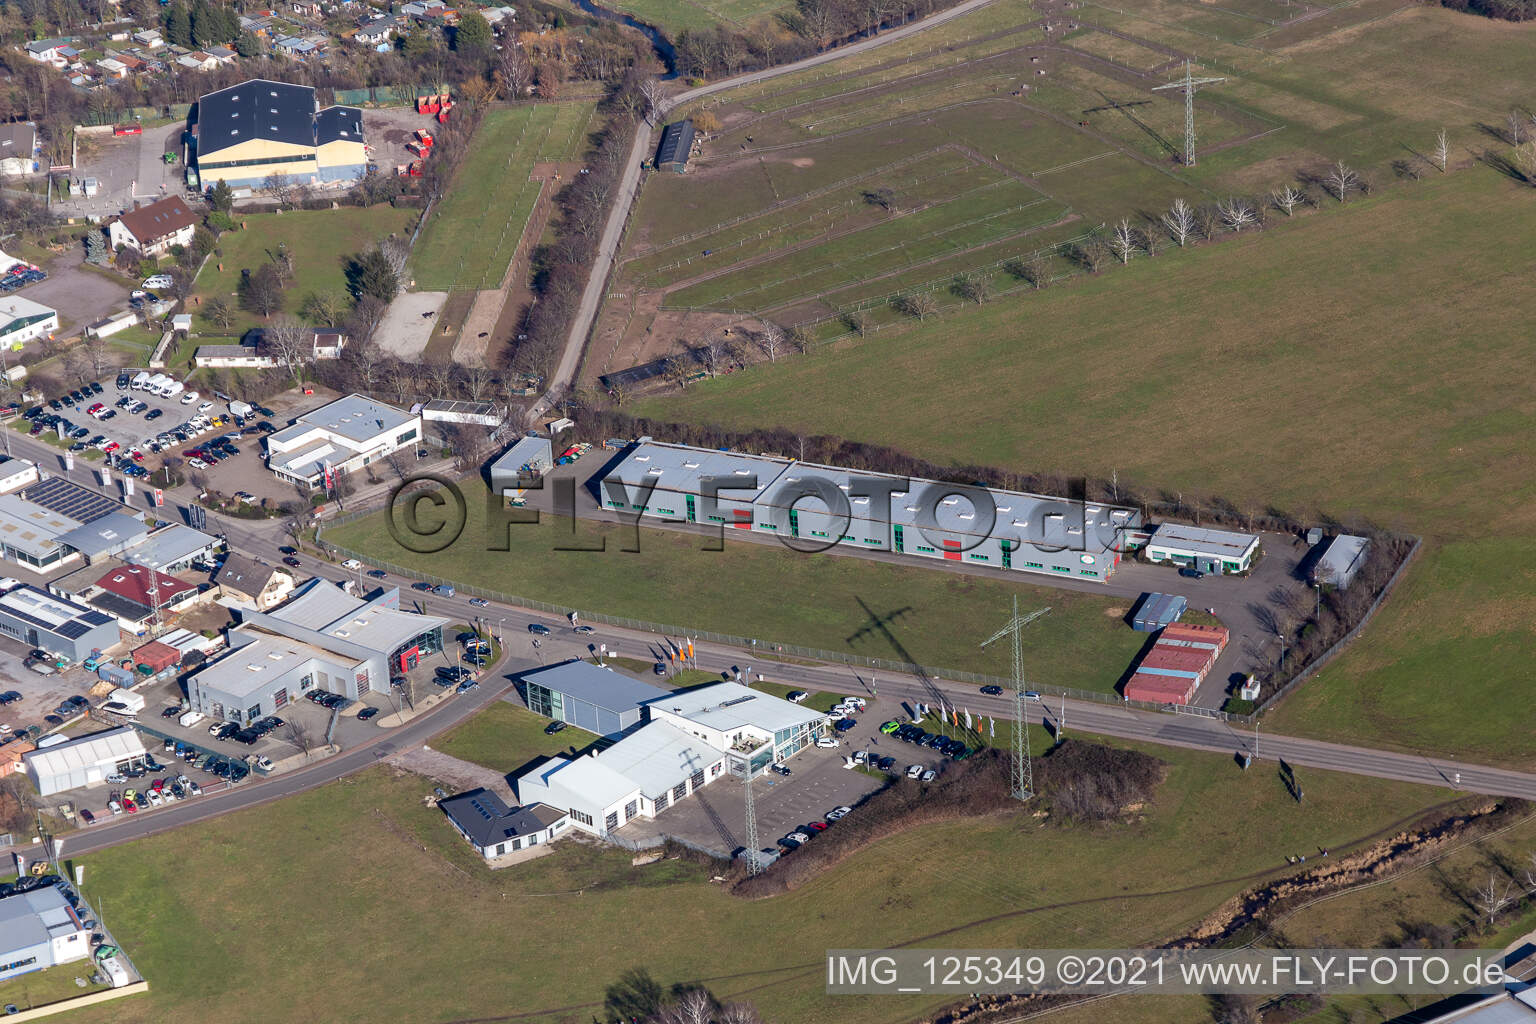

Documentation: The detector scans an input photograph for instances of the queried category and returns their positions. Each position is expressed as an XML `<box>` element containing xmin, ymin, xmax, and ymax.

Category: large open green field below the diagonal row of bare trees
<box><xmin>637</xmin><ymin>169</ymin><xmax>1536</xmax><ymax>763</ymax></box>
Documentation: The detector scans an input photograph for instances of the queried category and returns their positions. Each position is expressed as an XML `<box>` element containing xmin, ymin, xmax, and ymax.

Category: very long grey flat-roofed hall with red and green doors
<box><xmin>599</xmin><ymin>441</ymin><xmax>1141</xmax><ymax>582</ymax></box>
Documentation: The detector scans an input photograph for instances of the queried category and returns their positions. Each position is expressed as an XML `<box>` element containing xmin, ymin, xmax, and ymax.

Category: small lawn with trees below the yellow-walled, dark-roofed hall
<box><xmin>189</xmin><ymin>206</ymin><xmax>415</xmax><ymax>334</ymax></box>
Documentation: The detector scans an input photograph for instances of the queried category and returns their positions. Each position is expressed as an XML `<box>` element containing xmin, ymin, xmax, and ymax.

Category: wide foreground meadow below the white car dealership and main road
<box><xmin>56</xmin><ymin>737</ymin><xmax>1435</xmax><ymax>1024</ymax></box>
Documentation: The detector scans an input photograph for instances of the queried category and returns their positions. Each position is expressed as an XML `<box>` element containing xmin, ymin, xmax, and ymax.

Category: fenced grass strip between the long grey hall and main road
<box><xmin>324</xmin><ymin>482</ymin><xmax>1146</xmax><ymax>692</ymax></box>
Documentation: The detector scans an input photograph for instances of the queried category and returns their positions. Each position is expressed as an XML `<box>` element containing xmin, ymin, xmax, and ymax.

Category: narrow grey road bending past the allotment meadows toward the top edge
<box><xmin>528</xmin><ymin>0</ymin><xmax>992</xmax><ymax>424</ymax></box>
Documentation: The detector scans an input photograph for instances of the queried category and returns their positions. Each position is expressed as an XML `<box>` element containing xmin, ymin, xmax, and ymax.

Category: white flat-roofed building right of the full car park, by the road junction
<box><xmin>267</xmin><ymin>395</ymin><xmax>421</xmax><ymax>488</ymax></box>
